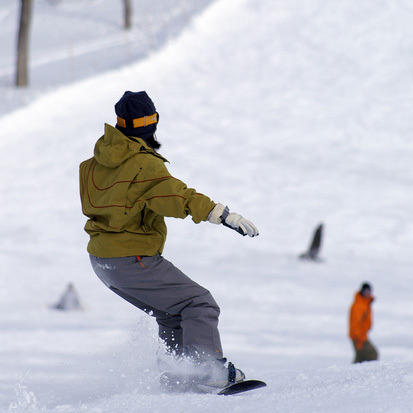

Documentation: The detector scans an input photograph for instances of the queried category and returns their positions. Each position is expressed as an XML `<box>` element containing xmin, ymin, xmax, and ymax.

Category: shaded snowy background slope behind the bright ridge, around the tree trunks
<box><xmin>0</xmin><ymin>0</ymin><xmax>213</xmax><ymax>113</ymax></box>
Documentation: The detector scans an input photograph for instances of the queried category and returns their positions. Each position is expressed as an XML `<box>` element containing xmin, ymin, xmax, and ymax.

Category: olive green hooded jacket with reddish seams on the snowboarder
<box><xmin>80</xmin><ymin>124</ymin><xmax>215</xmax><ymax>258</ymax></box>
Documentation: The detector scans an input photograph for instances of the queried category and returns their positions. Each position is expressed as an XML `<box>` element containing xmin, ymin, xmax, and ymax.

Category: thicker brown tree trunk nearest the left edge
<box><xmin>16</xmin><ymin>0</ymin><xmax>32</xmax><ymax>86</ymax></box>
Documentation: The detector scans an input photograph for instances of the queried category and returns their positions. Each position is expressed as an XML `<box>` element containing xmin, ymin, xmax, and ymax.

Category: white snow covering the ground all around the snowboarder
<box><xmin>0</xmin><ymin>0</ymin><xmax>413</xmax><ymax>413</ymax></box>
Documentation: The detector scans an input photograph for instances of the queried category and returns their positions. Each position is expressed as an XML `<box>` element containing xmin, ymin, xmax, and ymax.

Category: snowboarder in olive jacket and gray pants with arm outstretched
<box><xmin>80</xmin><ymin>91</ymin><xmax>258</xmax><ymax>387</ymax></box>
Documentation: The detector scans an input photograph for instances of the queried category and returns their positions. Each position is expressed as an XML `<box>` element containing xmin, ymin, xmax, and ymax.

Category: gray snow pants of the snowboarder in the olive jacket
<box><xmin>90</xmin><ymin>255</ymin><xmax>223</xmax><ymax>359</ymax></box>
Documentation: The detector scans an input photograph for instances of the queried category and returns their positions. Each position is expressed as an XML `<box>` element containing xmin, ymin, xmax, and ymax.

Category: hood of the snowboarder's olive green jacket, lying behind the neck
<box><xmin>94</xmin><ymin>123</ymin><xmax>167</xmax><ymax>168</ymax></box>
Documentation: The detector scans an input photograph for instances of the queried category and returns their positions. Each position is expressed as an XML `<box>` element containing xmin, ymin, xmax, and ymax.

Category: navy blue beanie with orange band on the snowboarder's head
<box><xmin>115</xmin><ymin>91</ymin><xmax>159</xmax><ymax>139</ymax></box>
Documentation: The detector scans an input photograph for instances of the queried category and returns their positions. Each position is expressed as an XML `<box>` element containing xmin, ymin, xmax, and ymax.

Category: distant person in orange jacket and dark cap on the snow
<box><xmin>349</xmin><ymin>283</ymin><xmax>378</xmax><ymax>363</ymax></box>
